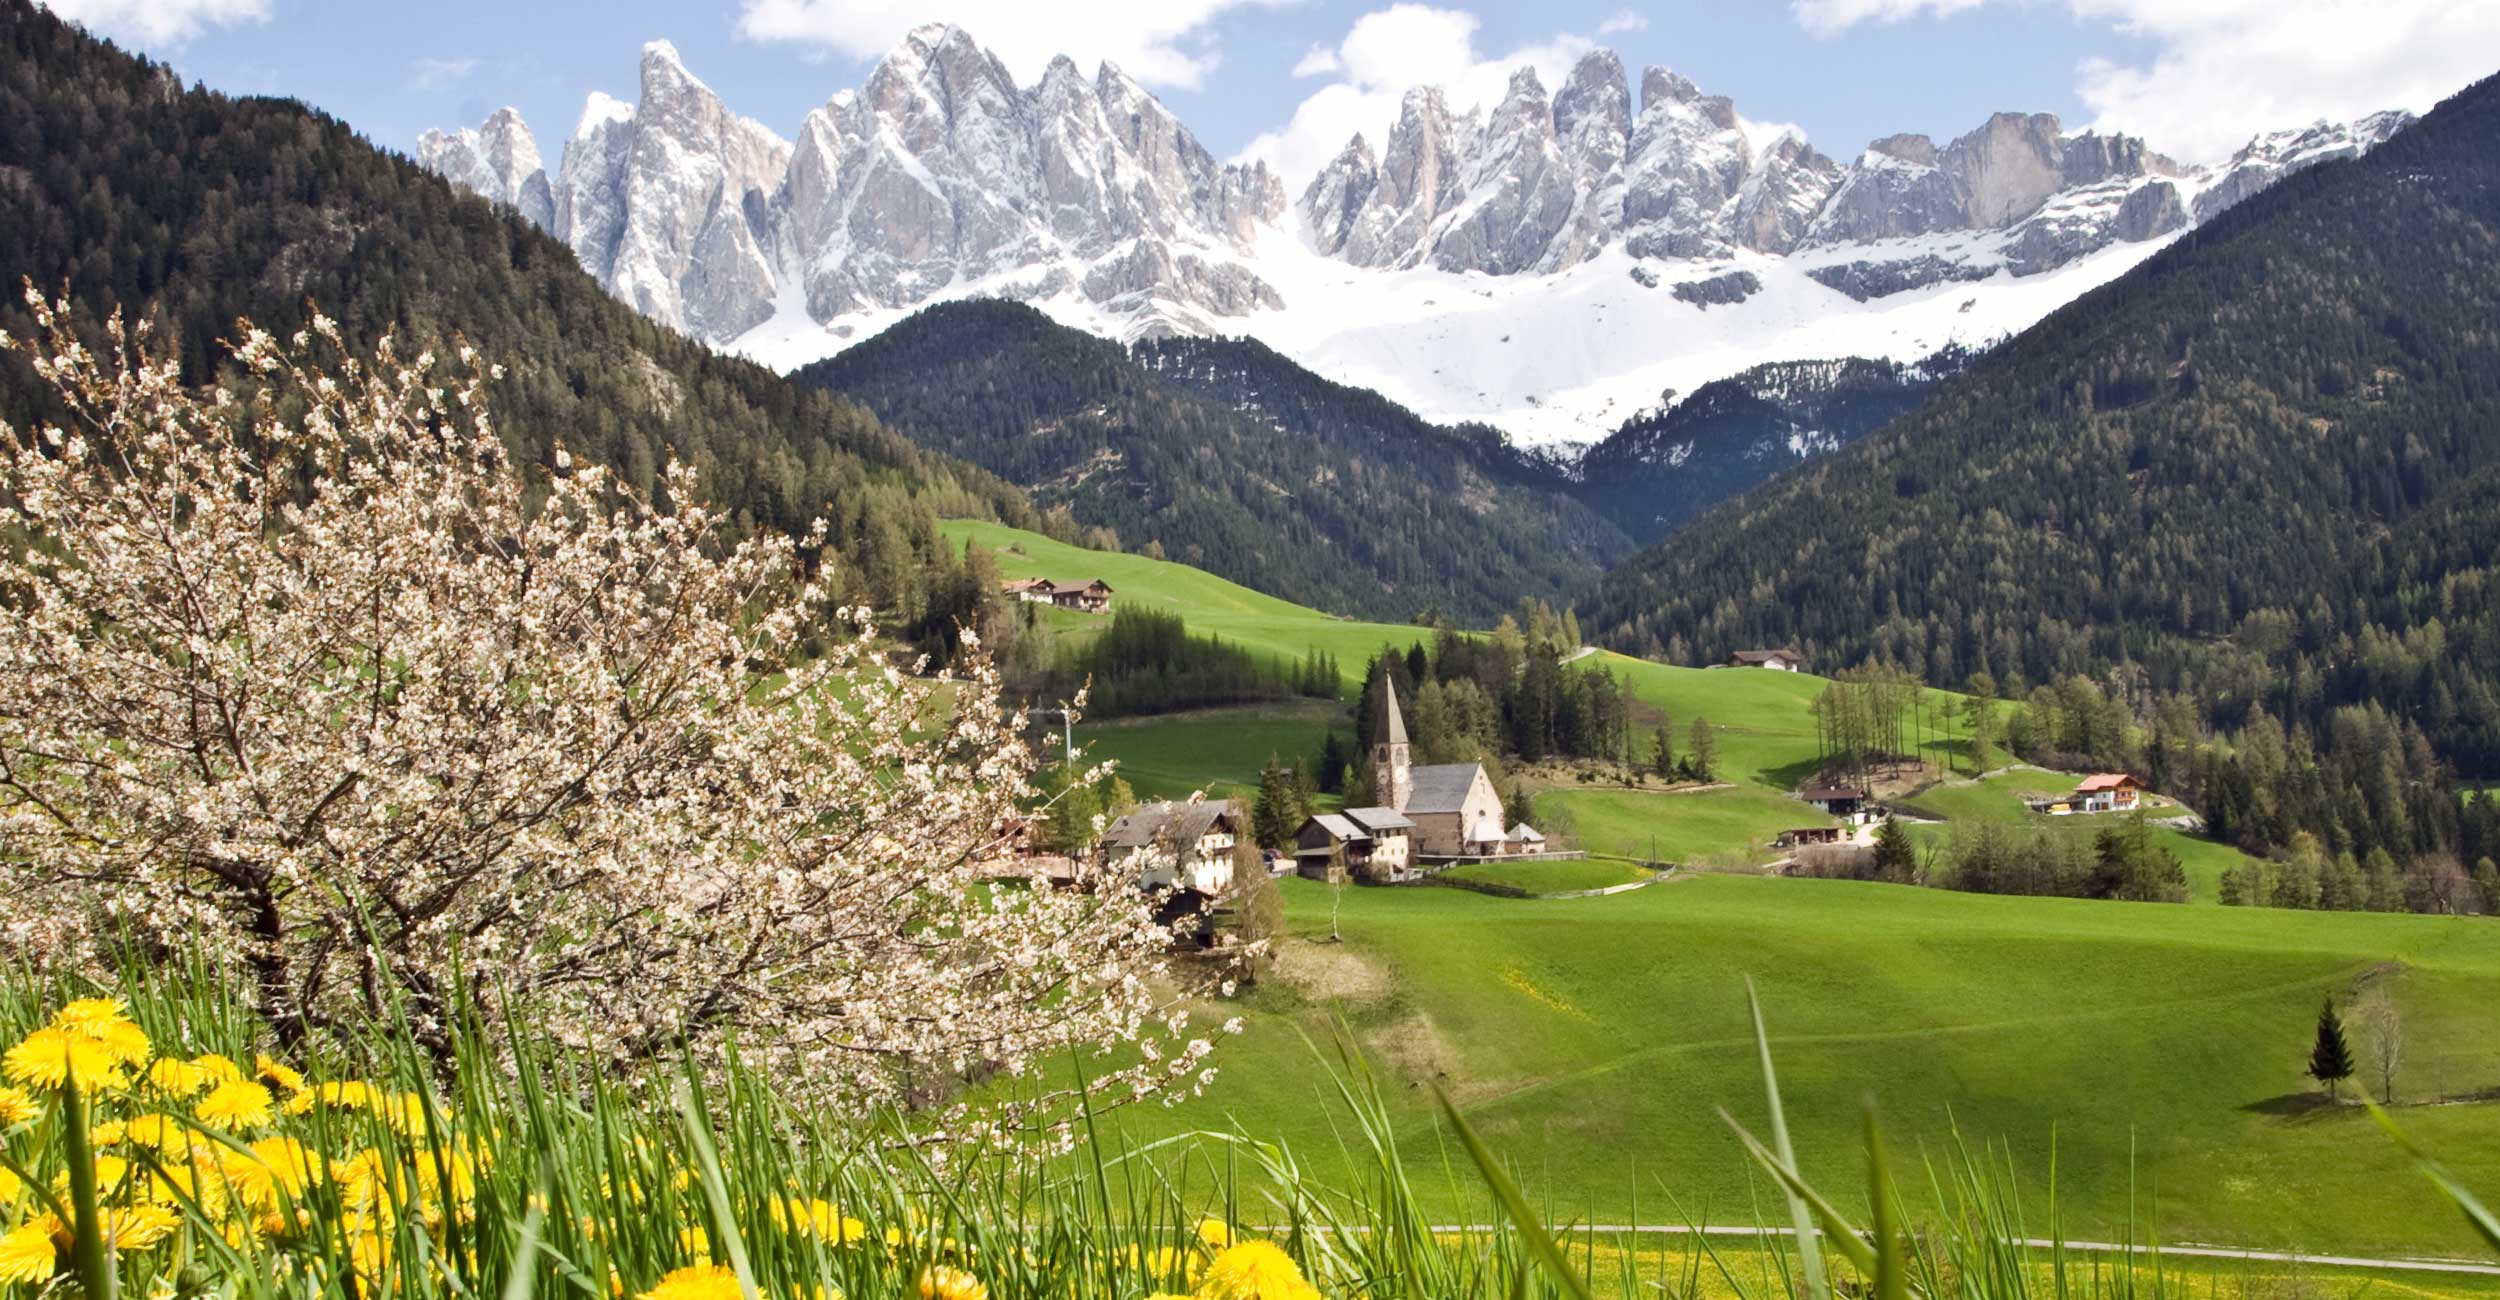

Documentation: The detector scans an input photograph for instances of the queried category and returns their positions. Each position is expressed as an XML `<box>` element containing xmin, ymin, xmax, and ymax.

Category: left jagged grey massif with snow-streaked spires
<box><xmin>418</xmin><ymin>25</ymin><xmax>1285</xmax><ymax>340</ymax></box>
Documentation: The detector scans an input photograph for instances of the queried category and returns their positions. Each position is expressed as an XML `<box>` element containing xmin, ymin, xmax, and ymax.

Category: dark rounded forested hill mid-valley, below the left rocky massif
<box><xmin>793</xmin><ymin>303</ymin><xmax>1630</xmax><ymax>623</ymax></box>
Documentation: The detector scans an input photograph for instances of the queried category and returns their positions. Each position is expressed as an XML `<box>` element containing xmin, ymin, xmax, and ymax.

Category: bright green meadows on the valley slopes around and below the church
<box><xmin>948</xmin><ymin>525</ymin><xmax>2500</xmax><ymax>1255</ymax></box>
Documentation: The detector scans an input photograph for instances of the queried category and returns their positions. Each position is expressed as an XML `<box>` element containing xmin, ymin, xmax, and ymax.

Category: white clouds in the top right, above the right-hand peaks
<box><xmin>1793</xmin><ymin>0</ymin><xmax>2500</xmax><ymax>160</ymax></box>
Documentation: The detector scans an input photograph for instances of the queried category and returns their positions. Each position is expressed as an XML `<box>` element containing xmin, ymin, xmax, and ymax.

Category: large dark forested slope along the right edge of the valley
<box><xmin>1583</xmin><ymin>80</ymin><xmax>2500</xmax><ymax>775</ymax></box>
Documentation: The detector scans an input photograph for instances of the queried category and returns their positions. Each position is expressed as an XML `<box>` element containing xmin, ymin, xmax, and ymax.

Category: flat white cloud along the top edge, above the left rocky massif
<box><xmin>738</xmin><ymin>0</ymin><xmax>1273</xmax><ymax>90</ymax></box>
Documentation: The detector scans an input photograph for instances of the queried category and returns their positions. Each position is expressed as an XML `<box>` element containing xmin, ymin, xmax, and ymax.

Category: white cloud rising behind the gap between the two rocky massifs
<box><xmin>1235</xmin><ymin>3</ymin><xmax>1598</xmax><ymax>193</ymax></box>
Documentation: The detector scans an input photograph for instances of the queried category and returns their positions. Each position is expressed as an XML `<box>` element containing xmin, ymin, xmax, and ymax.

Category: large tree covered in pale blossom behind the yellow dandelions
<box><xmin>0</xmin><ymin>290</ymin><xmax>1208</xmax><ymax>1140</ymax></box>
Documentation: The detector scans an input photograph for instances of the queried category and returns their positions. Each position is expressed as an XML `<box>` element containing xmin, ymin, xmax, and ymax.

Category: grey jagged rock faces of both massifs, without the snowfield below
<box><xmin>418</xmin><ymin>25</ymin><xmax>2408</xmax><ymax>377</ymax></box>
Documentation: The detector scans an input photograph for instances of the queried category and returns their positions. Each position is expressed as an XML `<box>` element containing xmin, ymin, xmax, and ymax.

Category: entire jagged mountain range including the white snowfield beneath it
<box><xmin>418</xmin><ymin>23</ymin><xmax>2410</xmax><ymax>445</ymax></box>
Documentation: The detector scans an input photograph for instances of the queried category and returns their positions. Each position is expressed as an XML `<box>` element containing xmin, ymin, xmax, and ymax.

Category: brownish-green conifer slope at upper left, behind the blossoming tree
<box><xmin>0</xmin><ymin>0</ymin><xmax>1038</xmax><ymax>608</ymax></box>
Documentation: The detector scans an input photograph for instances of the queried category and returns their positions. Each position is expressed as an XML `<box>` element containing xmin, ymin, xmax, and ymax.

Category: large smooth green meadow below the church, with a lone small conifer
<box><xmin>1123</xmin><ymin>875</ymin><xmax>2500</xmax><ymax>1253</ymax></box>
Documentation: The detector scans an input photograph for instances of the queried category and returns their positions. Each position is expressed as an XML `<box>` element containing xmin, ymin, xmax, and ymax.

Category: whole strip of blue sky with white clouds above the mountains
<box><xmin>50</xmin><ymin>0</ymin><xmax>2500</xmax><ymax>178</ymax></box>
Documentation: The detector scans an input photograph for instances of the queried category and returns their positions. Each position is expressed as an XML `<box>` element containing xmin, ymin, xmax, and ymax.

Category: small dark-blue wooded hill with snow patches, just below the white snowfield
<box><xmin>1580</xmin><ymin>348</ymin><xmax>1970</xmax><ymax>543</ymax></box>
